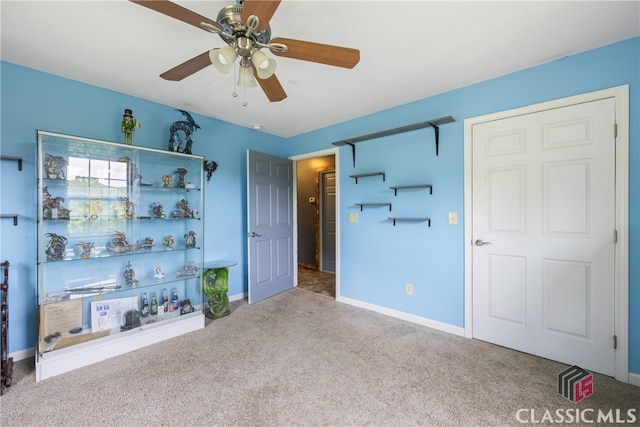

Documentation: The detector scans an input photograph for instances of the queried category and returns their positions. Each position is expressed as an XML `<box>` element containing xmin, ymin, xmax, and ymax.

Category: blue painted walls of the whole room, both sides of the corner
<box><xmin>0</xmin><ymin>38</ymin><xmax>640</xmax><ymax>373</ymax></box>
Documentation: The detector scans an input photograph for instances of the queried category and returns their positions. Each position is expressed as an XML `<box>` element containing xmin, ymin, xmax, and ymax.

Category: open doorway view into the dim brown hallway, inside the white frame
<box><xmin>296</xmin><ymin>154</ymin><xmax>337</xmax><ymax>298</ymax></box>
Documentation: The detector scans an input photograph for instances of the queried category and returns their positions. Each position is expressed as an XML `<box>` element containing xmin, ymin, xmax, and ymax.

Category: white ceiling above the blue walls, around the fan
<box><xmin>0</xmin><ymin>0</ymin><xmax>640</xmax><ymax>137</ymax></box>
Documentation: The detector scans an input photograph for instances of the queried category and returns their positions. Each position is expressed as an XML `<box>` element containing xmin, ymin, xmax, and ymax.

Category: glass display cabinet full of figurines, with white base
<box><xmin>36</xmin><ymin>131</ymin><xmax>204</xmax><ymax>381</ymax></box>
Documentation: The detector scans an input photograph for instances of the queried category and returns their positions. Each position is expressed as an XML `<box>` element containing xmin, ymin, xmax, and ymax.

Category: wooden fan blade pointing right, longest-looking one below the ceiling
<box><xmin>271</xmin><ymin>37</ymin><xmax>360</xmax><ymax>68</ymax></box>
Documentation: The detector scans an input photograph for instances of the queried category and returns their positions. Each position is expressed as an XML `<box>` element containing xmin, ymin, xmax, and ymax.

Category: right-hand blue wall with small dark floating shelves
<box><xmin>289</xmin><ymin>38</ymin><xmax>640</xmax><ymax>373</ymax></box>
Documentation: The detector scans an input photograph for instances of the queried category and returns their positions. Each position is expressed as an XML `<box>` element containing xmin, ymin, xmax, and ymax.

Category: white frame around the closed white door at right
<box><xmin>464</xmin><ymin>85</ymin><xmax>629</xmax><ymax>383</ymax></box>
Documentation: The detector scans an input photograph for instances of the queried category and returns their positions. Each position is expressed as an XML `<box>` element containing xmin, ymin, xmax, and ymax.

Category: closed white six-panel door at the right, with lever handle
<box><xmin>472</xmin><ymin>98</ymin><xmax>615</xmax><ymax>375</ymax></box>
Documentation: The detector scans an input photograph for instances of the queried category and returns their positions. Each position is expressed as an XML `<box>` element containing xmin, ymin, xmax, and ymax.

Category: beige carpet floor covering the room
<box><xmin>0</xmin><ymin>289</ymin><xmax>640</xmax><ymax>426</ymax></box>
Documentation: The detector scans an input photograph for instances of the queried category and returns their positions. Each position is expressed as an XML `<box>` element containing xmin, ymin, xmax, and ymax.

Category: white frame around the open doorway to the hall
<box><xmin>289</xmin><ymin>147</ymin><xmax>340</xmax><ymax>300</ymax></box>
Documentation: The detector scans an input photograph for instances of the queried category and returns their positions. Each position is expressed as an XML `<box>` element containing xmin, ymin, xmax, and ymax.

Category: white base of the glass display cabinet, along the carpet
<box><xmin>36</xmin><ymin>311</ymin><xmax>204</xmax><ymax>381</ymax></box>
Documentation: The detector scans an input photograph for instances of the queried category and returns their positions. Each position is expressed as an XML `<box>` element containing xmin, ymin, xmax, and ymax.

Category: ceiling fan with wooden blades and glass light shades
<box><xmin>130</xmin><ymin>0</ymin><xmax>360</xmax><ymax>102</ymax></box>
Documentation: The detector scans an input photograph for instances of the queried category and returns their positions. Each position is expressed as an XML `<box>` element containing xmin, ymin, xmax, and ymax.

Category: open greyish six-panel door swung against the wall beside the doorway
<box><xmin>247</xmin><ymin>150</ymin><xmax>293</xmax><ymax>304</ymax></box>
